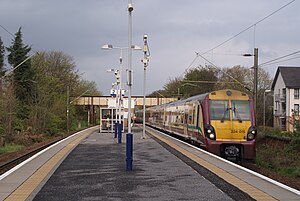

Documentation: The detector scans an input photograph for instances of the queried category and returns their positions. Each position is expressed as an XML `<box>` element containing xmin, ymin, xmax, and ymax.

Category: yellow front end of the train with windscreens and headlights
<box><xmin>203</xmin><ymin>90</ymin><xmax>257</xmax><ymax>159</ymax></box>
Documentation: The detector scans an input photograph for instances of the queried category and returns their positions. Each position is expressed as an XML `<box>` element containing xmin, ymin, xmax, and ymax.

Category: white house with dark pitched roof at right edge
<box><xmin>272</xmin><ymin>66</ymin><xmax>300</xmax><ymax>131</ymax></box>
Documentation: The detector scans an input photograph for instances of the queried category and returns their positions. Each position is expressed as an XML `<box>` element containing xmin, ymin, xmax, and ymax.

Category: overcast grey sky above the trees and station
<box><xmin>0</xmin><ymin>0</ymin><xmax>300</xmax><ymax>95</ymax></box>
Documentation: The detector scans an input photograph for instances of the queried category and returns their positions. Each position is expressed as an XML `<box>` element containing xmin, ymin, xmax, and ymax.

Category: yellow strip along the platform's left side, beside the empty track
<box><xmin>5</xmin><ymin>130</ymin><xmax>92</xmax><ymax>201</ymax></box>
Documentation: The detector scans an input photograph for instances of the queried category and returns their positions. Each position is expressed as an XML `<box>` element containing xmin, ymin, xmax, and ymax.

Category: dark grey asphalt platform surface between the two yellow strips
<box><xmin>29</xmin><ymin>128</ymin><xmax>252</xmax><ymax>201</ymax></box>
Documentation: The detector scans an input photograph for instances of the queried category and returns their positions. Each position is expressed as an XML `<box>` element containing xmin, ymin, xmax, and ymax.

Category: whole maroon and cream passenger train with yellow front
<box><xmin>137</xmin><ymin>89</ymin><xmax>257</xmax><ymax>160</ymax></box>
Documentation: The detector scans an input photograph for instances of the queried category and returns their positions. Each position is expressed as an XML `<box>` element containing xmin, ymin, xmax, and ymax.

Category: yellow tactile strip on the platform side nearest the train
<box><xmin>147</xmin><ymin>129</ymin><xmax>276</xmax><ymax>201</ymax></box>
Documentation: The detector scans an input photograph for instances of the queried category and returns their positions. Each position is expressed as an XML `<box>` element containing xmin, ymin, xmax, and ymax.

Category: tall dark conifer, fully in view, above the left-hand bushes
<box><xmin>7</xmin><ymin>28</ymin><xmax>36</xmax><ymax>119</ymax></box>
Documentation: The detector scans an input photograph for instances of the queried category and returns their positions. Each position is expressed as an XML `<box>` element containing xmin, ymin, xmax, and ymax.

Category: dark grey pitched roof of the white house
<box><xmin>272</xmin><ymin>66</ymin><xmax>300</xmax><ymax>90</ymax></box>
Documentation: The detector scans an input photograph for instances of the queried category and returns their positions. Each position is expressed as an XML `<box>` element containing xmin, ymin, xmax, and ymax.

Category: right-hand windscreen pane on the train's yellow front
<box><xmin>231</xmin><ymin>100</ymin><xmax>251</xmax><ymax>121</ymax></box>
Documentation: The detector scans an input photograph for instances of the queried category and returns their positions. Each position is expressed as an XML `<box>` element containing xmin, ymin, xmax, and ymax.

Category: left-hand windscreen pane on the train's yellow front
<box><xmin>210</xmin><ymin>100</ymin><xmax>230</xmax><ymax>121</ymax></box>
